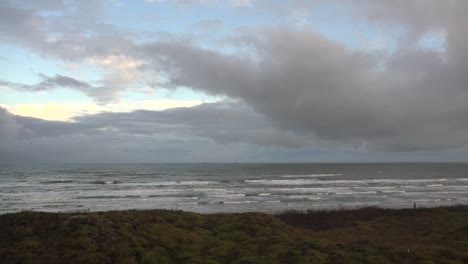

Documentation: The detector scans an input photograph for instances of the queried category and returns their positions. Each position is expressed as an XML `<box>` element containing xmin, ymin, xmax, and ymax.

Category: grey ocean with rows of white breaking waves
<box><xmin>0</xmin><ymin>163</ymin><xmax>468</xmax><ymax>214</ymax></box>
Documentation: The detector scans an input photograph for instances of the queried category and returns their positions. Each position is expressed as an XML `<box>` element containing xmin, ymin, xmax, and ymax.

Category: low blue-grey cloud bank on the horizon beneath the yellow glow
<box><xmin>0</xmin><ymin>102</ymin><xmax>326</xmax><ymax>162</ymax></box>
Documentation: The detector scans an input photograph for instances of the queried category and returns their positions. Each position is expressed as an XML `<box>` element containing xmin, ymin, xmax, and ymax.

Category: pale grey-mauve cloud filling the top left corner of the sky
<box><xmin>0</xmin><ymin>0</ymin><xmax>133</xmax><ymax>61</ymax></box>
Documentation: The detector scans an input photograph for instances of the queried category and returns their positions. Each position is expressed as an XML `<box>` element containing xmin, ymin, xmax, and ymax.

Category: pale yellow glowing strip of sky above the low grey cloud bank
<box><xmin>1</xmin><ymin>100</ymin><xmax>203</xmax><ymax>121</ymax></box>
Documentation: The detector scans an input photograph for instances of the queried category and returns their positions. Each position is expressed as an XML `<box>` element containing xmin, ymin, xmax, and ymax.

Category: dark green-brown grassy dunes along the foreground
<box><xmin>0</xmin><ymin>206</ymin><xmax>468</xmax><ymax>264</ymax></box>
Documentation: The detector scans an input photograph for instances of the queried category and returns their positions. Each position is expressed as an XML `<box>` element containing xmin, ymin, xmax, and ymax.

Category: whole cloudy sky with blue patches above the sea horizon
<box><xmin>0</xmin><ymin>0</ymin><xmax>468</xmax><ymax>163</ymax></box>
